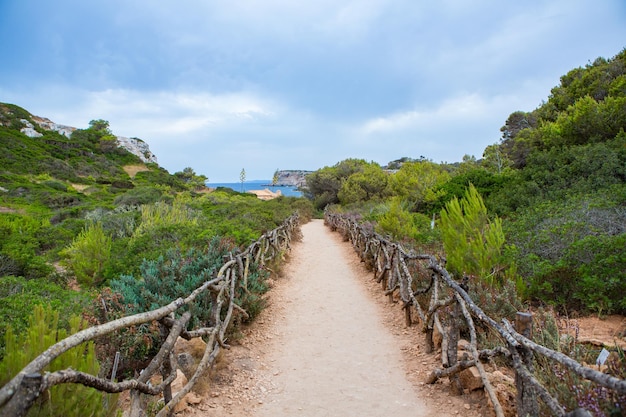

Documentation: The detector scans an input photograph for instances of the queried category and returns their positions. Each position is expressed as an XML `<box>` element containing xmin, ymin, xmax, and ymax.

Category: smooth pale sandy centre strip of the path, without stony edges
<box><xmin>251</xmin><ymin>220</ymin><xmax>425</xmax><ymax>417</ymax></box>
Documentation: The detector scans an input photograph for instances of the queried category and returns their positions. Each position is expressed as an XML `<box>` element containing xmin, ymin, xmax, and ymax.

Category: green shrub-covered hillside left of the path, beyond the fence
<box><xmin>0</xmin><ymin>104</ymin><xmax>312</xmax><ymax>364</ymax></box>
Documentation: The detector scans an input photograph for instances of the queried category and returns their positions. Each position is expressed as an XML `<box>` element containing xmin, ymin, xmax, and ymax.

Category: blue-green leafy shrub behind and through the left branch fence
<box><xmin>100</xmin><ymin>237</ymin><xmax>269</xmax><ymax>372</ymax></box>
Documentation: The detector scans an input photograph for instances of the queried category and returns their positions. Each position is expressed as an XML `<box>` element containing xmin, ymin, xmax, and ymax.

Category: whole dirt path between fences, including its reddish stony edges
<box><xmin>185</xmin><ymin>220</ymin><xmax>489</xmax><ymax>417</ymax></box>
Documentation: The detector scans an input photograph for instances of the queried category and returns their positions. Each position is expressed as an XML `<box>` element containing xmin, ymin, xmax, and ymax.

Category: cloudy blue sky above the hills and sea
<box><xmin>0</xmin><ymin>0</ymin><xmax>626</xmax><ymax>182</ymax></box>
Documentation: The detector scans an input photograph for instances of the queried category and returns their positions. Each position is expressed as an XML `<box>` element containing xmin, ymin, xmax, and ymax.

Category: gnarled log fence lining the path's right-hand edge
<box><xmin>325</xmin><ymin>212</ymin><xmax>626</xmax><ymax>417</ymax></box>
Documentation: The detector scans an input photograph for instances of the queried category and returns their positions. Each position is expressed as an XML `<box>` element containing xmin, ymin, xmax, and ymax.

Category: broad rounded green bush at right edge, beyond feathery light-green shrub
<box><xmin>507</xmin><ymin>191</ymin><xmax>626</xmax><ymax>313</ymax></box>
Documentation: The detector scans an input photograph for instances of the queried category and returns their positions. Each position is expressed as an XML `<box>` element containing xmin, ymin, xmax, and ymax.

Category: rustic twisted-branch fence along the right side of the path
<box><xmin>322</xmin><ymin>213</ymin><xmax>626</xmax><ymax>417</ymax></box>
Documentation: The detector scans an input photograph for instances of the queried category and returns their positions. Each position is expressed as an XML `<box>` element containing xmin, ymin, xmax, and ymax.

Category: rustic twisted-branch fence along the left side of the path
<box><xmin>0</xmin><ymin>213</ymin><xmax>300</xmax><ymax>417</ymax></box>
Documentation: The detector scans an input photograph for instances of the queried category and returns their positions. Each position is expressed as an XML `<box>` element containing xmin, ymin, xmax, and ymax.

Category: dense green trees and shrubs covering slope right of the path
<box><xmin>307</xmin><ymin>49</ymin><xmax>626</xmax><ymax>313</ymax></box>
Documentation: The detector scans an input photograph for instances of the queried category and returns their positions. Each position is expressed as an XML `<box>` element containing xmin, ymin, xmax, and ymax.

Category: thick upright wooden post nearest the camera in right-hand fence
<box><xmin>515</xmin><ymin>312</ymin><xmax>539</xmax><ymax>417</ymax></box>
